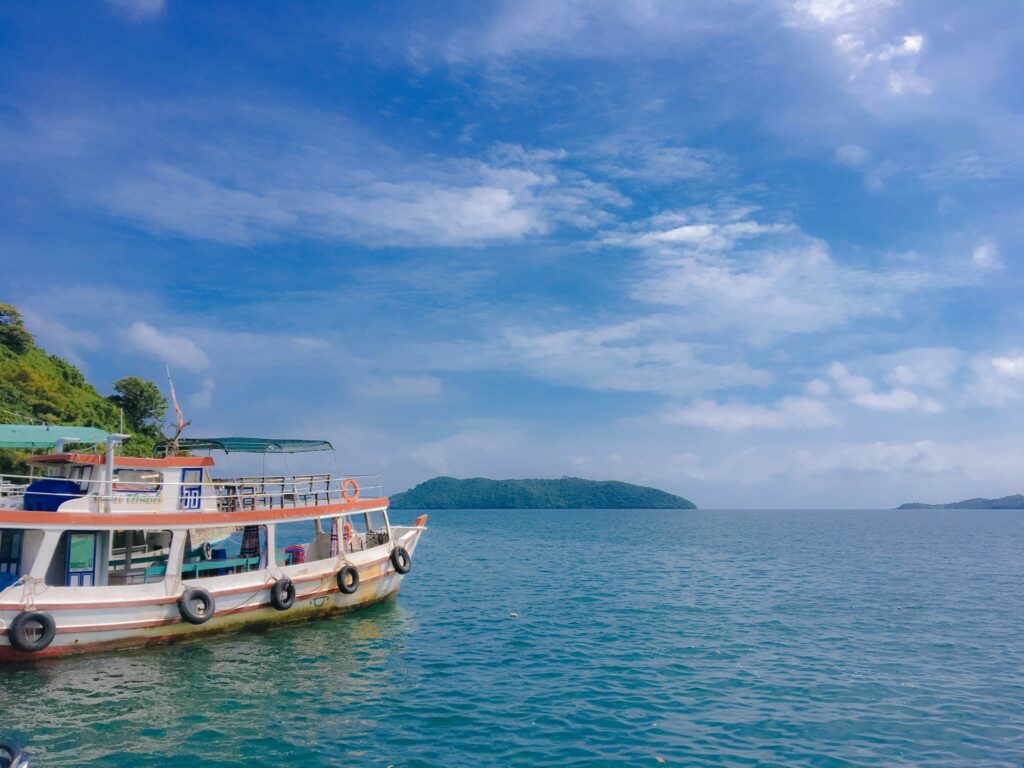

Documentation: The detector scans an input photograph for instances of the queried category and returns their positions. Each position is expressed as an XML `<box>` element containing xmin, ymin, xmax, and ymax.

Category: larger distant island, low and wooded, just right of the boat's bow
<box><xmin>390</xmin><ymin>477</ymin><xmax>696</xmax><ymax>509</ymax></box>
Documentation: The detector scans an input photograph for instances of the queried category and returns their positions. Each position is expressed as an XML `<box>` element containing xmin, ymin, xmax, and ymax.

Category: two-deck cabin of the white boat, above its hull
<box><xmin>0</xmin><ymin>430</ymin><xmax>392</xmax><ymax>592</ymax></box>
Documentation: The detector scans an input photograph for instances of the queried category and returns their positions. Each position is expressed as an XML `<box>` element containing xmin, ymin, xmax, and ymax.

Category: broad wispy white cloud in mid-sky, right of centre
<box><xmin>599</xmin><ymin>207</ymin><xmax>959</xmax><ymax>338</ymax></box>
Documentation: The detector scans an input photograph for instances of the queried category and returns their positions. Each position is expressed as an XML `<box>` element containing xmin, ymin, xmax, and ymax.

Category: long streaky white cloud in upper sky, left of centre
<box><xmin>97</xmin><ymin>145</ymin><xmax>629</xmax><ymax>247</ymax></box>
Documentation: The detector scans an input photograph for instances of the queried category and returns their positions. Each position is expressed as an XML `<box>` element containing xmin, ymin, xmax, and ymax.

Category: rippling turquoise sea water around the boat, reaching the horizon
<box><xmin>0</xmin><ymin>510</ymin><xmax>1024</xmax><ymax>768</ymax></box>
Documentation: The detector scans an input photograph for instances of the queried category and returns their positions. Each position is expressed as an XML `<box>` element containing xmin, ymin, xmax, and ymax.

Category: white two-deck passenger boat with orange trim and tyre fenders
<box><xmin>0</xmin><ymin>426</ymin><xmax>426</xmax><ymax>659</ymax></box>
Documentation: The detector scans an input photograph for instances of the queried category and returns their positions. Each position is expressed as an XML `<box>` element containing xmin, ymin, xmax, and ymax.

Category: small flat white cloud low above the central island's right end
<box><xmin>663</xmin><ymin>397</ymin><xmax>839</xmax><ymax>432</ymax></box>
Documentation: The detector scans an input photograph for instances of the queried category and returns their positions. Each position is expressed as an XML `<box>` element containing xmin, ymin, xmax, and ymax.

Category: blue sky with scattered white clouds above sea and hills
<box><xmin>0</xmin><ymin>0</ymin><xmax>1024</xmax><ymax>507</ymax></box>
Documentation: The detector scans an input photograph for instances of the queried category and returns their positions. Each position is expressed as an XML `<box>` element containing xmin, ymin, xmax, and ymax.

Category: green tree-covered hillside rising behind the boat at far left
<box><xmin>0</xmin><ymin>304</ymin><xmax>167</xmax><ymax>473</ymax></box>
